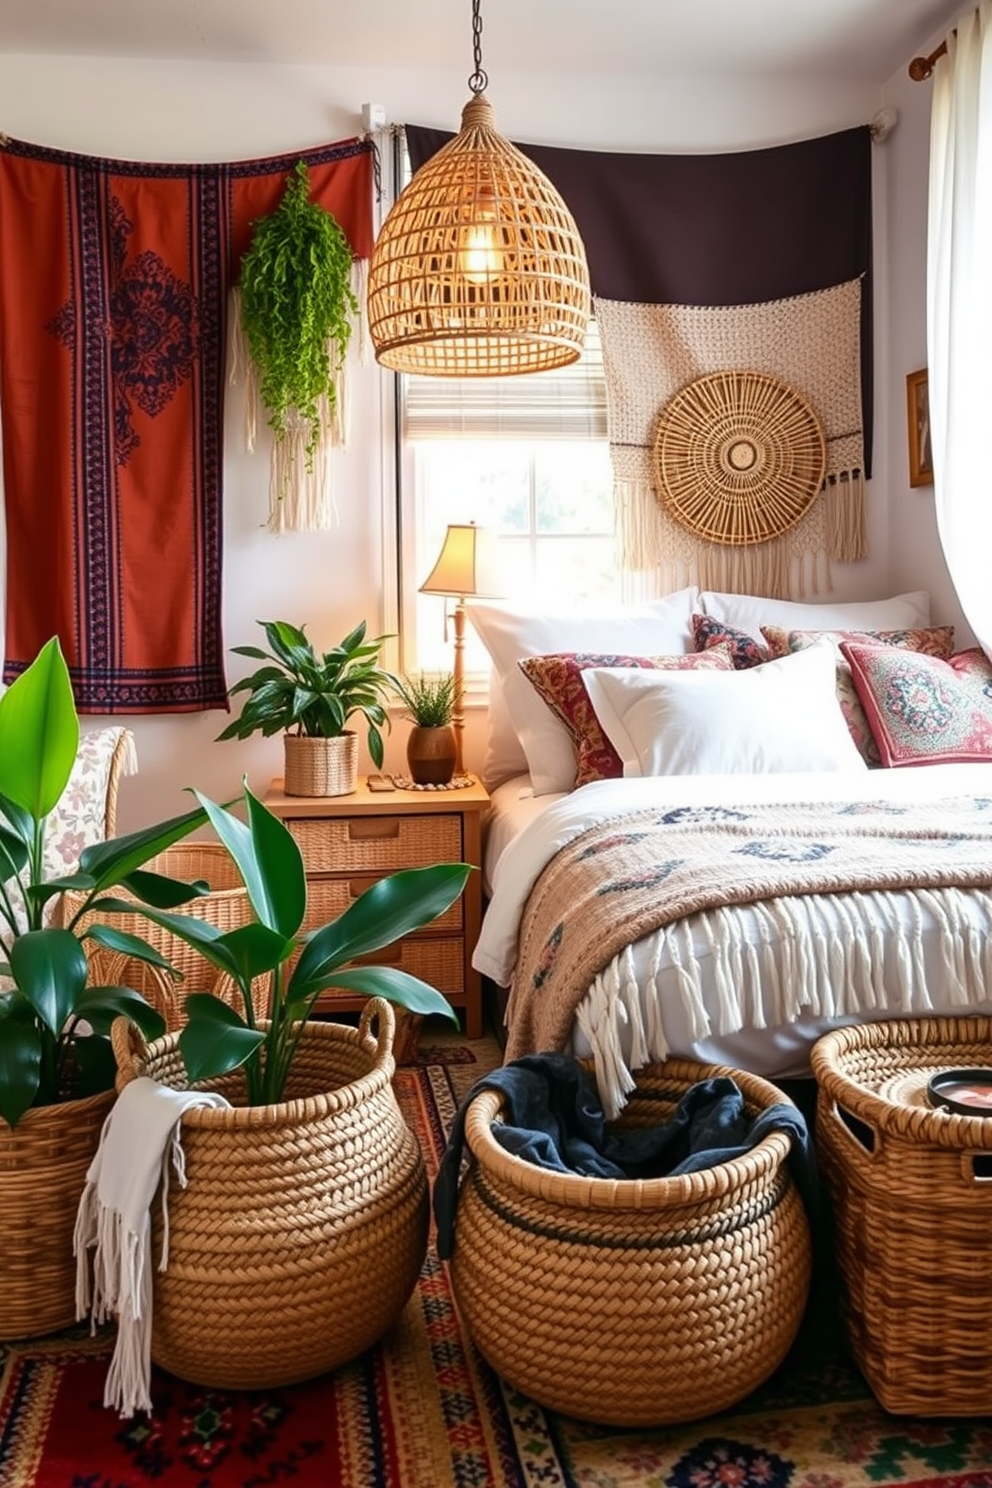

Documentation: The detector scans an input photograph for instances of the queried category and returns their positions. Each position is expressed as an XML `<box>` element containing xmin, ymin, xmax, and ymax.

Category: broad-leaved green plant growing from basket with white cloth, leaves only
<box><xmin>110</xmin><ymin>787</ymin><xmax>471</xmax><ymax>1106</ymax></box>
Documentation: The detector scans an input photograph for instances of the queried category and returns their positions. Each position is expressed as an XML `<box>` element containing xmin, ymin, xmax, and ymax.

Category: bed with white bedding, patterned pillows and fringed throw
<box><xmin>473</xmin><ymin>591</ymin><xmax>992</xmax><ymax>1113</ymax></box>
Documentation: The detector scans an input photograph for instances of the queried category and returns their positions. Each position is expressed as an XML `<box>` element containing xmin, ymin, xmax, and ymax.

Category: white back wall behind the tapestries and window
<box><xmin>0</xmin><ymin>55</ymin><xmax>904</xmax><ymax>830</ymax></box>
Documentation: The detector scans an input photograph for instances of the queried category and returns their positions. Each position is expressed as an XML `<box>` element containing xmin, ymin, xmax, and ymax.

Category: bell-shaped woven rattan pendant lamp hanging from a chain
<box><xmin>369</xmin><ymin>0</ymin><xmax>590</xmax><ymax>376</ymax></box>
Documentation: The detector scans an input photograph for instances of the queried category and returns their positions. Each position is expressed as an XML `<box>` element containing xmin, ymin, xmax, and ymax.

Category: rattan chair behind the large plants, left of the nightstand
<box><xmin>59</xmin><ymin>842</ymin><xmax>268</xmax><ymax>1028</ymax></box>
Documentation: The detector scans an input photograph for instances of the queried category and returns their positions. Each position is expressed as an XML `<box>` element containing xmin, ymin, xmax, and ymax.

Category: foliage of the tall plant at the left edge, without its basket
<box><xmin>0</xmin><ymin>640</ymin><xmax>207</xmax><ymax>1126</ymax></box>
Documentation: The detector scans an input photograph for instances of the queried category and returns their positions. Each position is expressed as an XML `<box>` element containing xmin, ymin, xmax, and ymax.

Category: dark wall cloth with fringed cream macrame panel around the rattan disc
<box><xmin>406</xmin><ymin>125</ymin><xmax>873</xmax><ymax>595</ymax></box>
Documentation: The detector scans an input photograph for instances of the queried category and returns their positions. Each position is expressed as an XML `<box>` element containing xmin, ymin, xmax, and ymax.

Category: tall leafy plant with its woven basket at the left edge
<box><xmin>0</xmin><ymin>640</ymin><xmax>205</xmax><ymax>1338</ymax></box>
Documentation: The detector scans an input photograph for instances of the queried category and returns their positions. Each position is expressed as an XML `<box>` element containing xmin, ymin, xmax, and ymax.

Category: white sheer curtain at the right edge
<box><xmin>927</xmin><ymin>0</ymin><xmax>992</xmax><ymax>655</ymax></box>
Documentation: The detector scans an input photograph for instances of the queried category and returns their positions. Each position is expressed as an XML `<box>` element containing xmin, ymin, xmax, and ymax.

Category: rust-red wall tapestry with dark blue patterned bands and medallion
<box><xmin>0</xmin><ymin>138</ymin><xmax>373</xmax><ymax>714</ymax></box>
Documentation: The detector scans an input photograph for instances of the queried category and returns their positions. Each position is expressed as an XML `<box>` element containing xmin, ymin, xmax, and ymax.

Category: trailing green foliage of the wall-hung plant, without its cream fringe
<box><xmin>241</xmin><ymin>161</ymin><xmax>358</xmax><ymax>470</ymax></box>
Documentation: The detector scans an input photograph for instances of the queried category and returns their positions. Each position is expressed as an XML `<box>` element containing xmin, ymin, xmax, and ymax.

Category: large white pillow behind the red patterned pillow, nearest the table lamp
<box><xmin>466</xmin><ymin>585</ymin><xmax>699</xmax><ymax>795</ymax></box>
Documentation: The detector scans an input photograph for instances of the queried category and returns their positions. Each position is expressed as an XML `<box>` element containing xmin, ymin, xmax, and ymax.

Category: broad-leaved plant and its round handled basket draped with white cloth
<box><xmin>104</xmin><ymin>789</ymin><xmax>470</xmax><ymax>1388</ymax></box>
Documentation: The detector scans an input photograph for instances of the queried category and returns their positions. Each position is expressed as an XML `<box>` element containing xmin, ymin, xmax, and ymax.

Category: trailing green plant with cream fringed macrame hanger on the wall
<box><xmin>231</xmin><ymin>161</ymin><xmax>366</xmax><ymax>533</ymax></box>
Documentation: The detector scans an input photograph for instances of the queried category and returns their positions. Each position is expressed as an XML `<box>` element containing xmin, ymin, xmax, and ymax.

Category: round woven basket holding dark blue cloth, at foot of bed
<box><xmin>452</xmin><ymin>1059</ymin><xmax>811</xmax><ymax>1426</ymax></box>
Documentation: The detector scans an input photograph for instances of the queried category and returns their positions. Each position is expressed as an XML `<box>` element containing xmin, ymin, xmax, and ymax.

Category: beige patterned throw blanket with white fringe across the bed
<box><xmin>506</xmin><ymin>798</ymin><xmax>992</xmax><ymax>1104</ymax></box>
